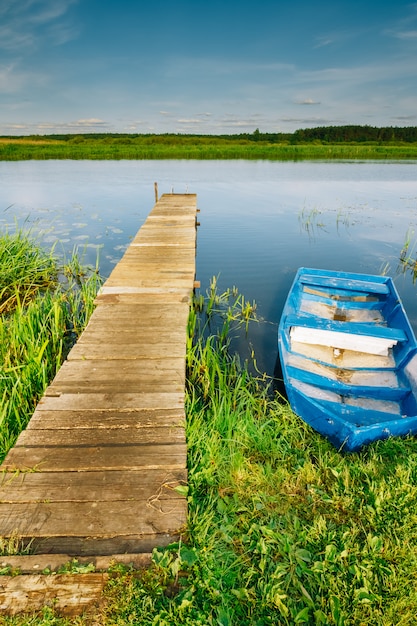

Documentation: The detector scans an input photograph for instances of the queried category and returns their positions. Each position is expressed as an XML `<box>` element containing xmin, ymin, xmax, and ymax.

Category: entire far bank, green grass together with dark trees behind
<box><xmin>0</xmin><ymin>126</ymin><xmax>417</xmax><ymax>161</ymax></box>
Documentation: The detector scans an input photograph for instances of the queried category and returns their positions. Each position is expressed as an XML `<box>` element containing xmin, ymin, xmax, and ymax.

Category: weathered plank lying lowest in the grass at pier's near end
<box><xmin>0</xmin><ymin>573</ymin><xmax>109</xmax><ymax>617</ymax></box>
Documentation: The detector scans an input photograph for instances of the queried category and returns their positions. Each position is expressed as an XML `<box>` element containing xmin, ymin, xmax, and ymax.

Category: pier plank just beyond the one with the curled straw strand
<box><xmin>2</xmin><ymin>442</ymin><xmax>187</xmax><ymax>472</ymax></box>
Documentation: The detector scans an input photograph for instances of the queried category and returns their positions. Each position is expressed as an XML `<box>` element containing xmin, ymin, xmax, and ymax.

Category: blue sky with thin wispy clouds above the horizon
<box><xmin>0</xmin><ymin>0</ymin><xmax>417</xmax><ymax>135</ymax></box>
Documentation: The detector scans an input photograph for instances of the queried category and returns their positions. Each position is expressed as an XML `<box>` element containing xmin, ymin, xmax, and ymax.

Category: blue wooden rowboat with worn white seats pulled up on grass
<box><xmin>278</xmin><ymin>268</ymin><xmax>417</xmax><ymax>452</ymax></box>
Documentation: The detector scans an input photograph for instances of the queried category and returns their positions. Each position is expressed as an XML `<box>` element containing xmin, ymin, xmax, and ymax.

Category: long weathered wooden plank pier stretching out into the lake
<box><xmin>0</xmin><ymin>194</ymin><xmax>197</xmax><ymax>610</ymax></box>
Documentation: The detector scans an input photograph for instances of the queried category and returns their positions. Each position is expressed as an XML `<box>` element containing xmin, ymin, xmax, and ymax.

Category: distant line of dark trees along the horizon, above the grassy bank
<box><xmin>4</xmin><ymin>125</ymin><xmax>417</xmax><ymax>145</ymax></box>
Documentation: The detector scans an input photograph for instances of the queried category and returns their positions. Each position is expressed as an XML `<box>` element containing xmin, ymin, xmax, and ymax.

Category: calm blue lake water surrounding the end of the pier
<box><xmin>0</xmin><ymin>161</ymin><xmax>417</xmax><ymax>374</ymax></box>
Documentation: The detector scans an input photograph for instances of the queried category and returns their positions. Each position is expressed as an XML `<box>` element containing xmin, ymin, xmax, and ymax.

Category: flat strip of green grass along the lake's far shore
<box><xmin>0</xmin><ymin>135</ymin><xmax>417</xmax><ymax>161</ymax></box>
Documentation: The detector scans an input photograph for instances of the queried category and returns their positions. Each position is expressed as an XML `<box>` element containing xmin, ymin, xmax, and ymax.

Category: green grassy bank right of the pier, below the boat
<box><xmin>3</xmin><ymin>285</ymin><xmax>417</xmax><ymax>626</ymax></box>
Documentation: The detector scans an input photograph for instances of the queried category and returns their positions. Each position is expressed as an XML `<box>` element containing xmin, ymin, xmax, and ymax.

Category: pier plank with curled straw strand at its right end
<box><xmin>0</xmin><ymin>468</ymin><xmax>187</xmax><ymax>502</ymax></box>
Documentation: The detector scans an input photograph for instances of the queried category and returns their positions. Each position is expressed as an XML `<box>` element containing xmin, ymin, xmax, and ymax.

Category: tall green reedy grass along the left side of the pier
<box><xmin>0</xmin><ymin>232</ymin><xmax>100</xmax><ymax>460</ymax></box>
